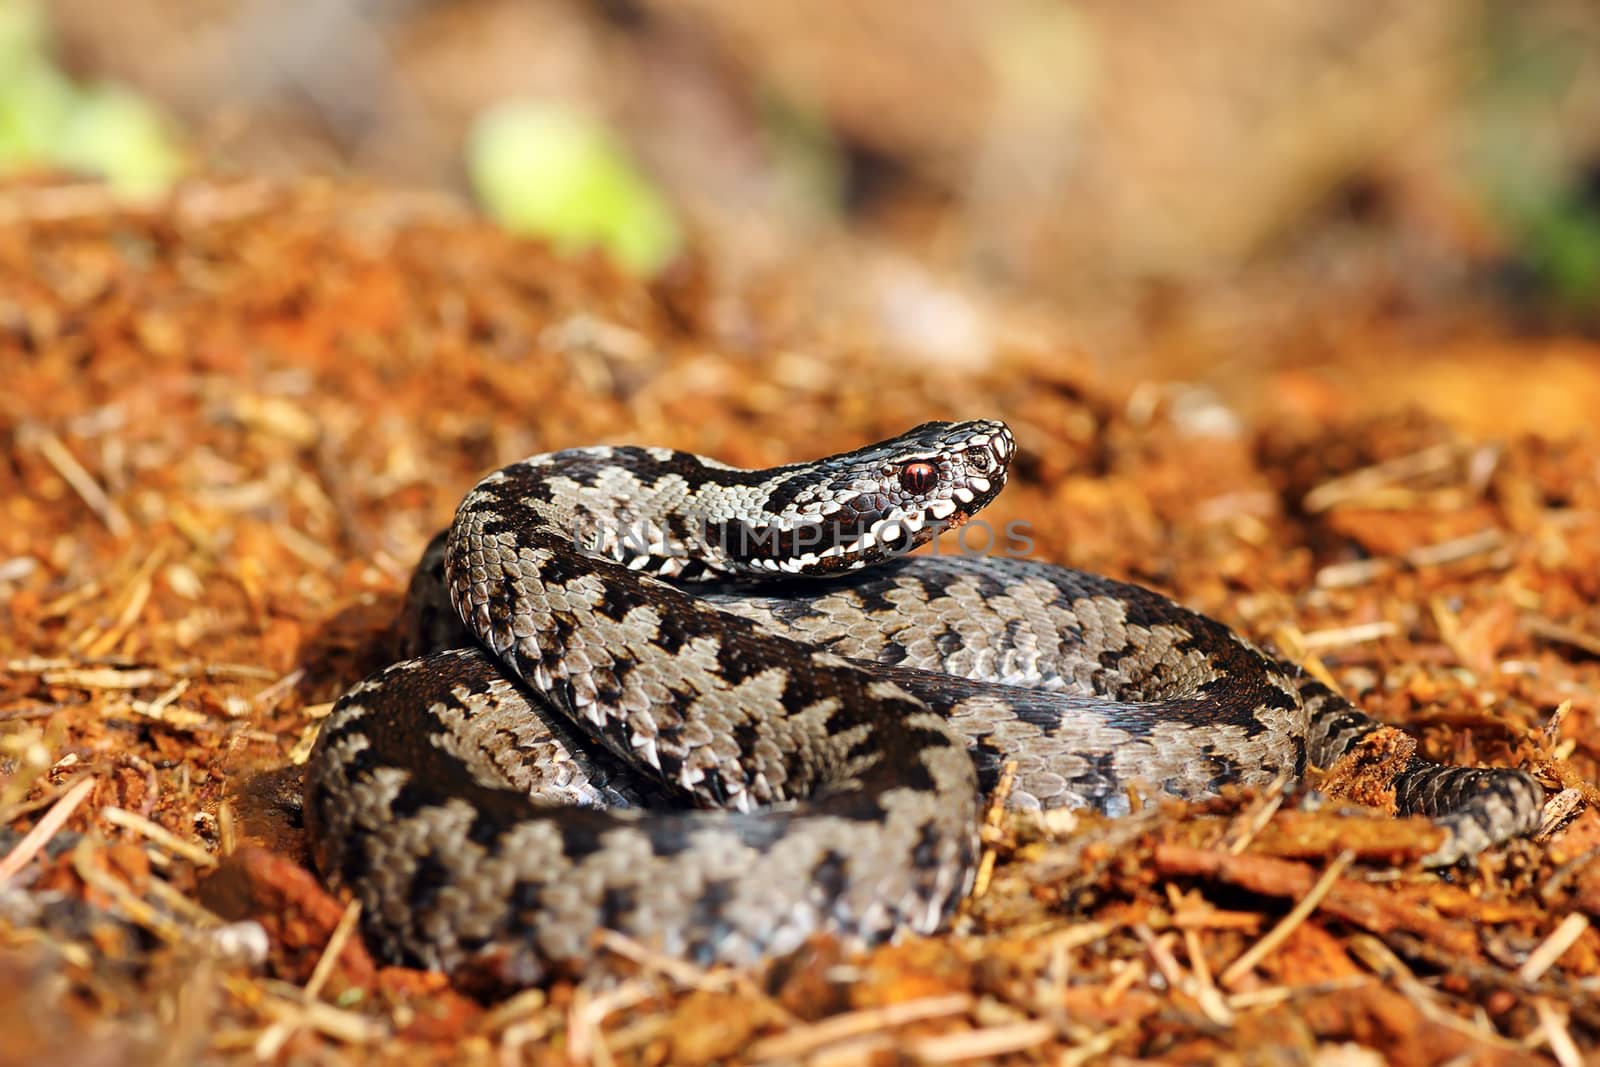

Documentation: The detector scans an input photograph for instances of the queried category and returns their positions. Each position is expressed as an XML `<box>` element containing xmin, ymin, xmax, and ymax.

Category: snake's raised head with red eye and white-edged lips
<box><xmin>730</xmin><ymin>419</ymin><xmax>1016</xmax><ymax>577</ymax></box>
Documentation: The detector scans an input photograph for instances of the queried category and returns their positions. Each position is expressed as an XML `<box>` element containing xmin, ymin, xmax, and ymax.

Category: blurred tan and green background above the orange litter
<box><xmin>0</xmin><ymin>0</ymin><xmax>1600</xmax><ymax>387</ymax></box>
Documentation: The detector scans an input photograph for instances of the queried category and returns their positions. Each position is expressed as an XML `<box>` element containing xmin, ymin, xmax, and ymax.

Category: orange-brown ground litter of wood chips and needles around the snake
<box><xmin>0</xmin><ymin>184</ymin><xmax>1600</xmax><ymax>1064</ymax></box>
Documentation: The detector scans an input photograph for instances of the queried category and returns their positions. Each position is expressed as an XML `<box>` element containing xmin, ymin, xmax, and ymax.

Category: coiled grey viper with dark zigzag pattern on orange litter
<box><xmin>302</xmin><ymin>419</ymin><xmax>1544</xmax><ymax>984</ymax></box>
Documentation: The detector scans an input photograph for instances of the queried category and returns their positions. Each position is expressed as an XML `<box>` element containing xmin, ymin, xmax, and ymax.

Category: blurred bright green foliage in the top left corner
<box><xmin>0</xmin><ymin>0</ymin><xmax>184</xmax><ymax>197</ymax></box>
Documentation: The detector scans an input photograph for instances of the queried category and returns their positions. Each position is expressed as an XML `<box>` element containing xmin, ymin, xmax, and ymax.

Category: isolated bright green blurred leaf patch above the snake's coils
<box><xmin>467</xmin><ymin>101</ymin><xmax>683</xmax><ymax>275</ymax></box>
